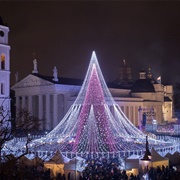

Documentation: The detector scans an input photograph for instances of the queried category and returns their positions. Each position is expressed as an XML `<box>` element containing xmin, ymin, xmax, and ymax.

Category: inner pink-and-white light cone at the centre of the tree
<box><xmin>73</xmin><ymin>63</ymin><xmax>115</xmax><ymax>152</ymax></box>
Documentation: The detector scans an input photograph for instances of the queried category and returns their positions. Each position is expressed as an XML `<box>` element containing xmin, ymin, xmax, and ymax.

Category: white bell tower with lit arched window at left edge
<box><xmin>0</xmin><ymin>17</ymin><xmax>10</xmax><ymax>115</ymax></box>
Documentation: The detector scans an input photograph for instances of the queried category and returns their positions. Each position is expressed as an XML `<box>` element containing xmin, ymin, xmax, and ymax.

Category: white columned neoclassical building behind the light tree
<box><xmin>11</xmin><ymin>59</ymin><xmax>174</xmax><ymax>131</ymax></box>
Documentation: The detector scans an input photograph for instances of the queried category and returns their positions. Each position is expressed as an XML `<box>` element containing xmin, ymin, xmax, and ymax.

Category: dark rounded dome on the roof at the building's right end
<box><xmin>131</xmin><ymin>79</ymin><xmax>155</xmax><ymax>93</ymax></box>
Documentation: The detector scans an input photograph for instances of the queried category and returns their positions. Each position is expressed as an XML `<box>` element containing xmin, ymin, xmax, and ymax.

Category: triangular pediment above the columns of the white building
<box><xmin>11</xmin><ymin>74</ymin><xmax>54</xmax><ymax>90</ymax></box>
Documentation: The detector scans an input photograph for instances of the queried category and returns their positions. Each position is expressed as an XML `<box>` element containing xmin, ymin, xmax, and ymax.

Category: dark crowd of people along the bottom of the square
<box><xmin>0</xmin><ymin>155</ymin><xmax>180</xmax><ymax>180</ymax></box>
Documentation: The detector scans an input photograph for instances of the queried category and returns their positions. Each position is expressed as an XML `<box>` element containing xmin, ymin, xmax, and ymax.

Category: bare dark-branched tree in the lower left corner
<box><xmin>0</xmin><ymin>106</ymin><xmax>41</xmax><ymax>179</ymax></box>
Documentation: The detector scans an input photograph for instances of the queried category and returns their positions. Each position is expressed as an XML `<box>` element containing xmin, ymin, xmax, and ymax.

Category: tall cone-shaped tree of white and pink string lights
<box><xmin>3</xmin><ymin>52</ymin><xmax>172</xmax><ymax>153</ymax></box>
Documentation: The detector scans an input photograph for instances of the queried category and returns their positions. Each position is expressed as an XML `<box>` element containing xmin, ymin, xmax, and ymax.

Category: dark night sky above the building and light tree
<box><xmin>0</xmin><ymin>1</ymin><xmax>180</xmax><ymax>85</ymax></box>
